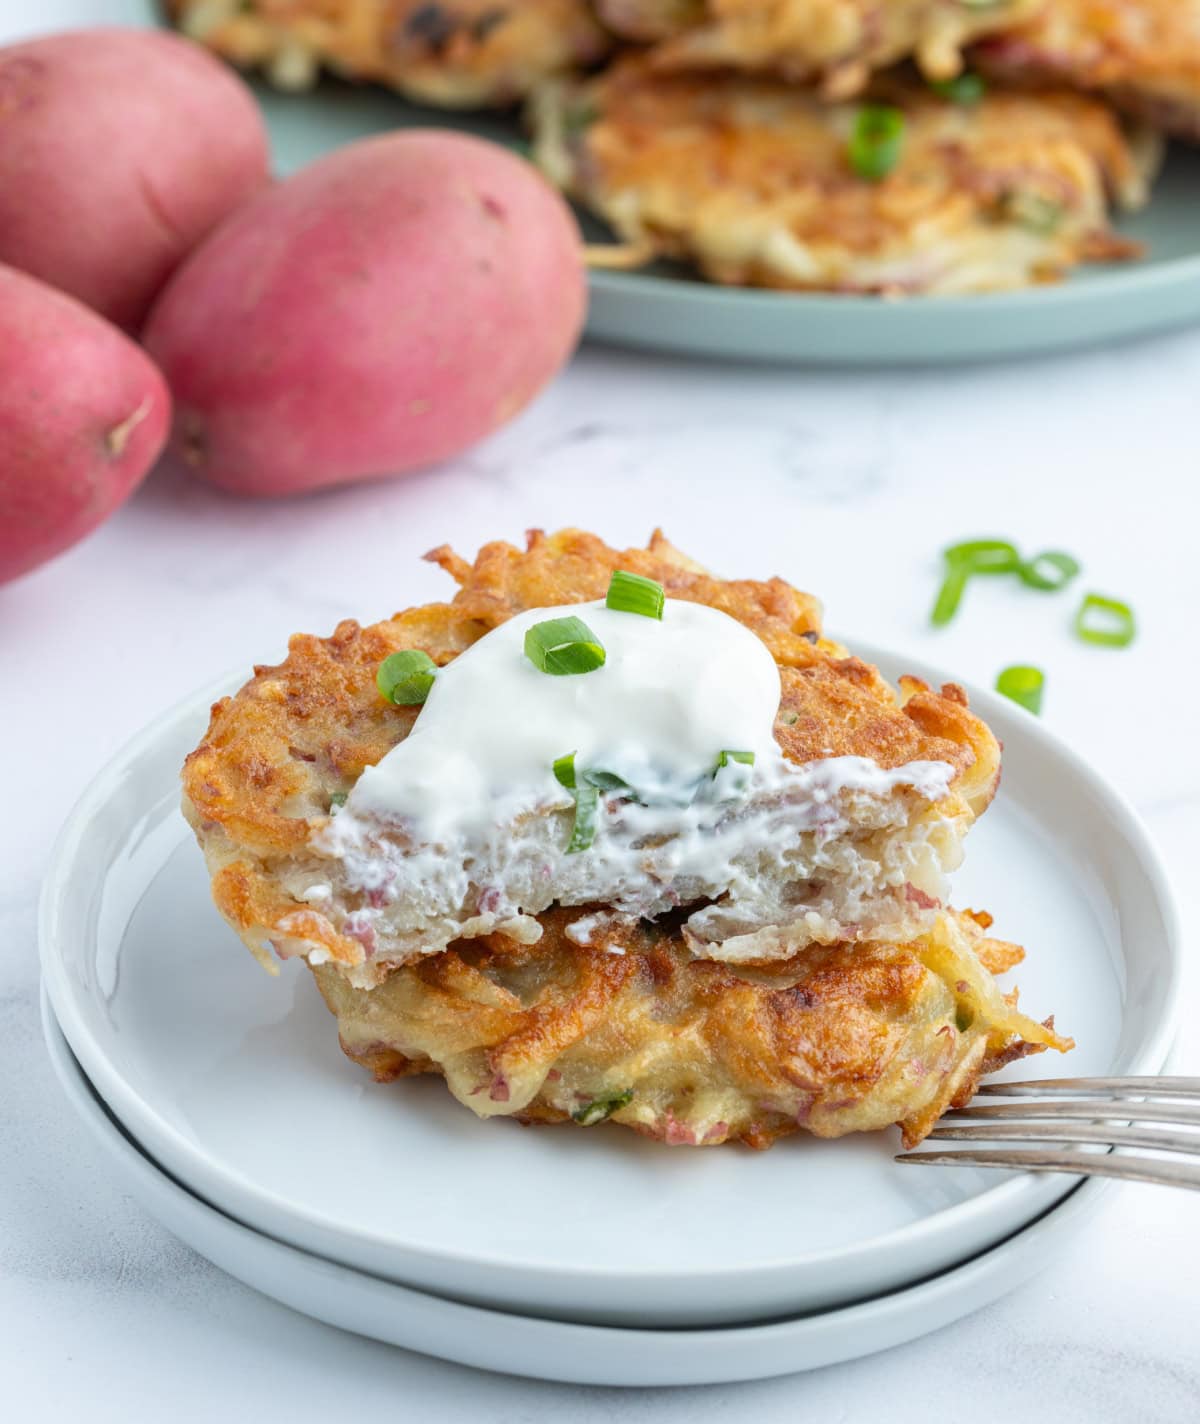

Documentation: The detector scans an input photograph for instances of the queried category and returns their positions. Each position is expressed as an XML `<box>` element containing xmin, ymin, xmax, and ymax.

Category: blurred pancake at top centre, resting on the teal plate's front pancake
<box><xmin>598</xmin><ymin>0</ymin><xmax>1043</xmax><ymax>98</ymax></box>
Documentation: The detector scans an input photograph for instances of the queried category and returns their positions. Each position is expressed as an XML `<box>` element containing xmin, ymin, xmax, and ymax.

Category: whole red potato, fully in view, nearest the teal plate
<box><xmin>144</xmin><ymin>130</ymin><xmax>586</xmax><ymax>496</ymax></box>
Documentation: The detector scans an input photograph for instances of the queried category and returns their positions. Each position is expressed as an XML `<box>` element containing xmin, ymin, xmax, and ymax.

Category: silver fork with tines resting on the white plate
<box><xmin>895</xmin><ymin>1078</ymin><xmax>1200</xmax><ymax>1190</ymax></box>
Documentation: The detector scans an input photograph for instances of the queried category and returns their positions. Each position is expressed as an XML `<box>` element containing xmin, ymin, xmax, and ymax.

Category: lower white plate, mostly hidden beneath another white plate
<box><xmin>43</xmin><ymin>998</ymin><xmax>1110</xmax><ymax>1386</ymax></box>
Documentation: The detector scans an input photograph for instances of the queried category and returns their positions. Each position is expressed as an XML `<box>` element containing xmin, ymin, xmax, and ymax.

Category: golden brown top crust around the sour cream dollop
<box><xmin>184</xmin><ymin>530</ymin><xmax>999</xmax><ymax>965</ymax></box>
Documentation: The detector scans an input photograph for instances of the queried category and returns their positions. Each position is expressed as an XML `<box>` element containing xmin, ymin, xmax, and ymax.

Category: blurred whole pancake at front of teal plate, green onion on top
<box><xmin>532</xmin><ymin>57</ymin><xmax>1157</xmax><ymax>293</ymax></box>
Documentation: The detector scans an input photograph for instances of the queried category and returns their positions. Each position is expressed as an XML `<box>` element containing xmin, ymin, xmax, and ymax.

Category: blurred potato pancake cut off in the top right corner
<box><xmin>974</xmin><ymin>0</ymin><xmax>1200</xmax><ymax>142</ymax></box>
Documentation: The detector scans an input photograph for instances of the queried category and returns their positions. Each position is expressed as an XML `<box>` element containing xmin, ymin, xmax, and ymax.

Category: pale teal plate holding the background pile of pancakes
<box><xmin>259</xmin><ymin>83</ymin><xmax>1200</xmax><ymax>366</ymax></box>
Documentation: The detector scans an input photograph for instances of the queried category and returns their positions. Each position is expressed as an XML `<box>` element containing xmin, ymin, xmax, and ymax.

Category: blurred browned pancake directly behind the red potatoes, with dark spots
<box><xmin>168</xmin><ymin>0</ymin><xmax>609</xmax><ymax>108</ymax></box>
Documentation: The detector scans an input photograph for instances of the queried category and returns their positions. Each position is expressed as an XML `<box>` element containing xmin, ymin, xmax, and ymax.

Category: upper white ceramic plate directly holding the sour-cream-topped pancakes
<box><xmin>41</xmin><ymin>645</ymin><xmax>1179</xmax><ymax>1326</ymax></box>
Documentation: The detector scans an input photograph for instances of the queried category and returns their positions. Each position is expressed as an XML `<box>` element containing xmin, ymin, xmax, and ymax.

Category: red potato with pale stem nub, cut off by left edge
<box><xmin>0</xmin><ymin>266</ymin><xmax>171</xmax><ymax>584</ymax></box>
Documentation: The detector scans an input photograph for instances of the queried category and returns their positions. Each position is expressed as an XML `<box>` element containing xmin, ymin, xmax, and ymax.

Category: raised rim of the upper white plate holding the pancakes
<box><xmin>37</xmin><ymin>639</ymin><xmax>1183</xmax><ymax>1283</ymax></box>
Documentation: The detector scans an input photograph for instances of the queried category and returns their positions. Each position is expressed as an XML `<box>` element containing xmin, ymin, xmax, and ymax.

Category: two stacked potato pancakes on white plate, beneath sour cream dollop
<box><xmin>184</xmin><ymin>531</ymin><xmax>1069</xmax><ymax>1146</ymax></box>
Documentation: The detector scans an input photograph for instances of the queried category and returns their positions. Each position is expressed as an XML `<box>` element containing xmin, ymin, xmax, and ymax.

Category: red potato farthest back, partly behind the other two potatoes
<box><xmin>0</xmin><ymin>28</ymin><xmax>268</xmax><ymax>332</ymax></box>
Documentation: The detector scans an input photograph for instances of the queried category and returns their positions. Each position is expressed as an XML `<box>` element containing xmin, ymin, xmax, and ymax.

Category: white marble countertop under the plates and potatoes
<box><xmin>0</xmin><ymin>332</ymin><xmax>1200</xmax><ymax>1424</ymax></box>
